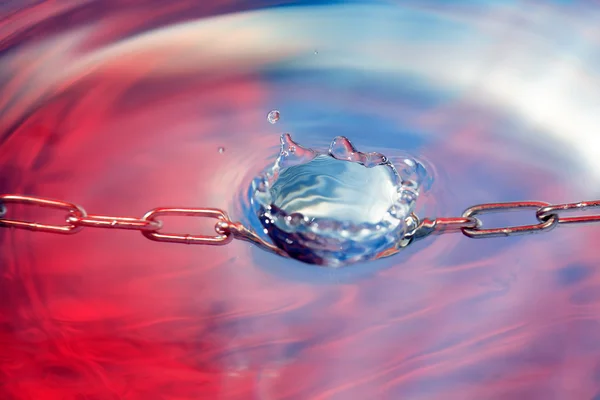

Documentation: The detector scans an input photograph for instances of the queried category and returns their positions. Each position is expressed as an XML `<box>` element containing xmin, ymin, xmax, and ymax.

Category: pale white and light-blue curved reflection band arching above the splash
<box><xmin>2</xmin><ymin>3</ymin><xmax>600</xmax><ymax>183</ymax></box>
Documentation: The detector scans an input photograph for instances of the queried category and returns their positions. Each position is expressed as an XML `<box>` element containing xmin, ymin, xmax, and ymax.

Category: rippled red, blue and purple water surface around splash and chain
<box><xmin>0</xmin><ymin>0</ymin><xmax>600</xmax><ymax>400</ymax></box>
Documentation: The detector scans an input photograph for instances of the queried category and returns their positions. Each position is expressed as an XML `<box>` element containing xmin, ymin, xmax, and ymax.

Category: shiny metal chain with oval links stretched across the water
<box><xmin>0</xmin><ymin>195</ymin><xmax>600</xmax><ymax>247</ymax></box>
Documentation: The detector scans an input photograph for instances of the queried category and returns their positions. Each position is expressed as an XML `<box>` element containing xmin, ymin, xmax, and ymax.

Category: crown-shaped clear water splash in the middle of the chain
<box><xmin>251</xmin><ymin>133</ymin><xmax>425</xmax><ymax>267</ymax></box>
